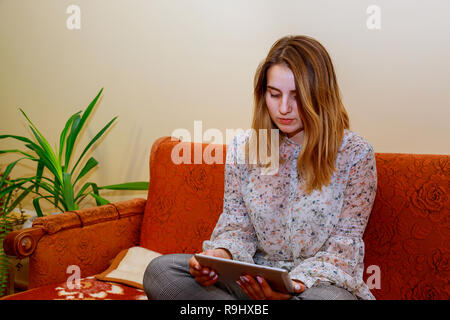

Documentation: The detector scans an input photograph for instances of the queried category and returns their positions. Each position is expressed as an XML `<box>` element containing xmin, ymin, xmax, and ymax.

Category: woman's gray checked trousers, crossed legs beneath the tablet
<box><xmin>143</xmin><ymin>254</ymin><xmax>357</xmax><ymax>300</ymax></box>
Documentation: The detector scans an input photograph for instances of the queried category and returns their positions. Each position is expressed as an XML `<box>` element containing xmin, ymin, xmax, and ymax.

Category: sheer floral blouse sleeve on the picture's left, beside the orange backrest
<box><xmin>203</xmin><ymin>137</ymin><xmax>256</xmax><ymax>263</ymax></box>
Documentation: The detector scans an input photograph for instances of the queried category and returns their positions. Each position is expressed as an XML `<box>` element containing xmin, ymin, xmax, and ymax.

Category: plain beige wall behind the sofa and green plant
<box><xmin>0</xmin><ymin>0</ymin><xmax>450</xmax><ymax>212</ymax></box>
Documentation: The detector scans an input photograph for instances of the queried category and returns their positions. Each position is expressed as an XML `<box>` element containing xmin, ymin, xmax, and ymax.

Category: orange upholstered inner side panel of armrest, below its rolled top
<box><xmin>29</xmin><ymin>217</ymin><xmax>142</xmax><ymax>288</ymax></box>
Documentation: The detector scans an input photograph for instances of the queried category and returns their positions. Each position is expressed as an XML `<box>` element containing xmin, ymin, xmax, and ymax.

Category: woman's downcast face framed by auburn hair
<box><xmin>265</xmin><ymin>64</ymin><xmax>303</xmax><ymax>138</ymax></box>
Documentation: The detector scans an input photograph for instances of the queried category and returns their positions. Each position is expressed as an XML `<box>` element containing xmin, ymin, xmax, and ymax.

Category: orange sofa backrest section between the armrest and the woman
<box><xmin>140</xmin><ymin>137</ymin><xmax>226</xmax><ymax>253</ymax></box>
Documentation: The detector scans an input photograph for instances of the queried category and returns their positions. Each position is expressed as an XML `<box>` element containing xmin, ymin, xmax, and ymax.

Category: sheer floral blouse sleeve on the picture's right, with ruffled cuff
<box><xmin>290</xmin><ymin>145</ymin><xmax>377</xmax><ymax>291</ymax></box>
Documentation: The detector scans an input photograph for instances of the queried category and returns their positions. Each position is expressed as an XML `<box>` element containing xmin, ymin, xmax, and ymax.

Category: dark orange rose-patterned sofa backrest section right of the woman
<box><xmin>364</xmin><ymin>153</ymin><xmax>450</xmax><ymax>300</ymax></box>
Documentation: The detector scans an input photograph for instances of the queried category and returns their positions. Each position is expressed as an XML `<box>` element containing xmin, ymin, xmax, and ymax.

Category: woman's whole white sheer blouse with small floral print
<box><xmin>203</xmin><ymin>130</ymin><xmax>377</xmax><ymax>299</ymax></box>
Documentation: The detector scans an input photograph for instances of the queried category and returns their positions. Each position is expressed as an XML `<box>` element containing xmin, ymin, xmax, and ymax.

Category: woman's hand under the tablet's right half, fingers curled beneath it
<box><xmin>236</xmin><ymin>274</ymin><xmax>306</xmax><ymax>300</ymax></box>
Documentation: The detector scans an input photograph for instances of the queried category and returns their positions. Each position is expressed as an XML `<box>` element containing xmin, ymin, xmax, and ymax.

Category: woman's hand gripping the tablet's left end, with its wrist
<box><xmin>189</xmin><ymin>249</ymin><xmax>231</xmax><ymax>287</ymax></box>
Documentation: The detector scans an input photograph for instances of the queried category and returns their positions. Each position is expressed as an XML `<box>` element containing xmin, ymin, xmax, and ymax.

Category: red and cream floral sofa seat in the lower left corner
<box><xmin>4</xmin><ymin>277</ymin><xmax>147</xmax><ymax>300</ymax></box>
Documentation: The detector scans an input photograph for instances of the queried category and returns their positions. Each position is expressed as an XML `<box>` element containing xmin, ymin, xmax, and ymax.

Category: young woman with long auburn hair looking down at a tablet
<box><xmin>144</xmin><ymin>36</ymin><xmax>377</xmax><ymax>299</ymax></box>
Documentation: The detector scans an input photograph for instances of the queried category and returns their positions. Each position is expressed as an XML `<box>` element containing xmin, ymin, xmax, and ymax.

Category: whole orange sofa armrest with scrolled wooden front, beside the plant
<box><xmin>3</xmin><ymin>198</ymin><xmax>146</xmax><ymax>289</ymax></box>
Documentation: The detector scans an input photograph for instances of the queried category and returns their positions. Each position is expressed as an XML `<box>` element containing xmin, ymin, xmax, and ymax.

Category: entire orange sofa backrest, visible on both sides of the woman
<box><xmin>140</xmin><ymin>137</ymin><xmax>450</xmax><ymax>299</ymax></box>
